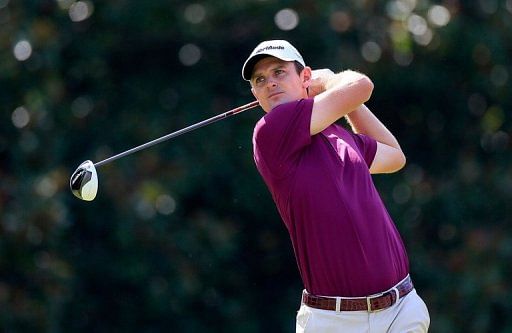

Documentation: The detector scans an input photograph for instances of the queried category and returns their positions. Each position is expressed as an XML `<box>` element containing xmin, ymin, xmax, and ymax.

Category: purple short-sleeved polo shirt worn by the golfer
<box><xmin>253</xmin><ymin>99</ymin><xmax>409</xmax><ymax>297</ymax></box>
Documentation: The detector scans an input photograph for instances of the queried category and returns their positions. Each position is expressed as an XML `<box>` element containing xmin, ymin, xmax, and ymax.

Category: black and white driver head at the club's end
<box><xmin>69</xmin><ymin>160</ymin><xmax>98</xmax><ymax>201</ymax></box>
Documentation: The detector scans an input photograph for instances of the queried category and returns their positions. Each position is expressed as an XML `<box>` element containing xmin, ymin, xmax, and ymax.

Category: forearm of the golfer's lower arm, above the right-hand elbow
<box><xmin>346</xmin><ymin>104</ymin><xmax>401</xmax><ymax>150</ymax></box>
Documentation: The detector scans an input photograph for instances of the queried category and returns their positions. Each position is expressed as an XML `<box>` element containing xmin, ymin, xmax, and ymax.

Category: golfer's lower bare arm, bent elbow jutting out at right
<box><xmin>346</xmin><ymin>105</ymin><xmax>405</xmax><ymax>173</ymax></box>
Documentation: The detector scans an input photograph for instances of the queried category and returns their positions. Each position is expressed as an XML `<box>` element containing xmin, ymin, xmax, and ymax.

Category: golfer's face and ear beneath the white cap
<box><xmin>251</xmin><ymin>57</ymin><xmax>311</xmax><ymax>112</ymax></box>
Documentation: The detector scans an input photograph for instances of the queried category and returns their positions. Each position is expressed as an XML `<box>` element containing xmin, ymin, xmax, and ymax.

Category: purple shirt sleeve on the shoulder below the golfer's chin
<box><xmin>253</xmin><ymin>99</ymin><xmax>313</xmax><ymax>179</ymax></box>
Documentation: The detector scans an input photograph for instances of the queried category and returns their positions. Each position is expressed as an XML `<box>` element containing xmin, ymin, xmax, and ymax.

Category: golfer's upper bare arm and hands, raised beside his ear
<box><xmin>308</xmin><ymin>69</ymin><xmax>373</xmax><ymax>135</ymax></box>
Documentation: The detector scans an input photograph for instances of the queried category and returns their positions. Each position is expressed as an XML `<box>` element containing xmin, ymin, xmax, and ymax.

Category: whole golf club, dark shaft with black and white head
<box><xmin>69</xmin><ymin>101</ymin><xmax>259</xmax><ymax>201</ymax></box>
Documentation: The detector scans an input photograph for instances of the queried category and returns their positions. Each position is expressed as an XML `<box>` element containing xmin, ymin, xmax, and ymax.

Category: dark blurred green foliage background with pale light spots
<box><xmin>0</xmin><ymin>0</ymin><xmax>512</xmax><ymax>333</ymax></box>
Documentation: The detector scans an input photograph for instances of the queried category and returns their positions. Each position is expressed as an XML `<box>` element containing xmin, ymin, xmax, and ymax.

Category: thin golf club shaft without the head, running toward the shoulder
<box><xmin>94</xmin><ymin>101</ymin><xmax>259</xmax><ymax>167</ymax></box>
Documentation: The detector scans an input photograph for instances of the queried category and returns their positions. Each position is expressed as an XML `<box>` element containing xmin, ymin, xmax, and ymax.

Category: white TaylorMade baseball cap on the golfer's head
<box><xmin>242</xmin><ymin>39</ymin><xmax>306</xmax><ymax>81</ymax></box>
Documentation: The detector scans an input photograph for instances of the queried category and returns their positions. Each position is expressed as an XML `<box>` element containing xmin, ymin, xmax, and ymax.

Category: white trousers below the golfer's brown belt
<box><xmin>295</xmin><ymin>290</ymin><xmax>430</xmax><ymax>333</ymax></box>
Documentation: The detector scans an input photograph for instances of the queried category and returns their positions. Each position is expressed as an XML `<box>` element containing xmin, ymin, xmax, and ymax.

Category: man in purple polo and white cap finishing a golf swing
<box><xmin>242</xmin><ymin>40</ymin><xmax>430</xmax><ymax>333</ymax></box>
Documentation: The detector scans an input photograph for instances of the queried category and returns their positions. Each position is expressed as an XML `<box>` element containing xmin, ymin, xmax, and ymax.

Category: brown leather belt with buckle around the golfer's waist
<box><xmin>302</xmin><ymin>276</ymin><xmax>414</xmax><ymax>312</ymax></box>
